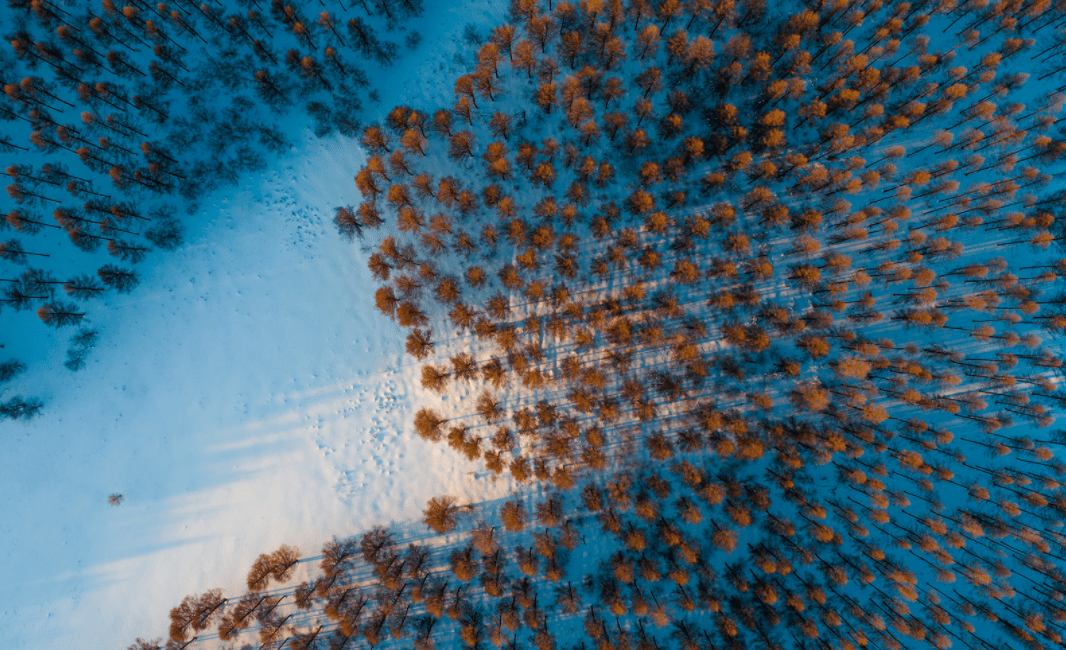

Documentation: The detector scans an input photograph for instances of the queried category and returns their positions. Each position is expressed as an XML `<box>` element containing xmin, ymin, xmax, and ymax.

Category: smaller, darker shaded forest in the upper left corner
<box><xmin>0</xmin><ymin>0</ymin><xmax>423</xmax><ymax>420</ymax></box>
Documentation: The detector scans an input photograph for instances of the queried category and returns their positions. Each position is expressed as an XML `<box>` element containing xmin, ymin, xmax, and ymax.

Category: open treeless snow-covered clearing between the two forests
<box><xmin>0</xmin><ymin>2</ymin><xmax>508</xmax><ymax>650</ymax></box>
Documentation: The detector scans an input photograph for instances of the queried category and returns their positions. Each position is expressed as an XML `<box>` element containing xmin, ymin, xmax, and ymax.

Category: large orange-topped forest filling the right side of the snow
<box><xmin>54</xmin><ymin>0</ymin><xmax>1066</xmax><ymax>650</ymax></box>
